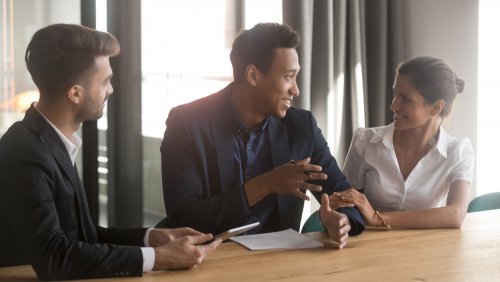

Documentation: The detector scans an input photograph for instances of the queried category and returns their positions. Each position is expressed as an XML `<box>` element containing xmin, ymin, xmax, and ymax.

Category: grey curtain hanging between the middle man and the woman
<box><xmin>283</xmin><ymin>0</ymin><xmax>404</xmax><ymax>163</ymax></box>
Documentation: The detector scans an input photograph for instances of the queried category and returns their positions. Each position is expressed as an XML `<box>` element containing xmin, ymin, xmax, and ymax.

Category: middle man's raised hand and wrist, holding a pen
<box><xmin>245</xmin><ymin>158</ymin><xmax>327</xmax><ymax>206</ymax></box>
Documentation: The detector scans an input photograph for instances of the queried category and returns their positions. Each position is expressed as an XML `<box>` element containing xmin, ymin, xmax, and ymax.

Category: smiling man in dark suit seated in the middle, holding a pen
<box><xmin>159</xmin><ymin>23</ymin><xmax>364</xmax><ymax>248</ymax></box>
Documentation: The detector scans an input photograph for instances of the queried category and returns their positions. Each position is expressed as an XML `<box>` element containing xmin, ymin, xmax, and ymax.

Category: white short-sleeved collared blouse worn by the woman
<box><xmin>344</xmin><ymin>123</ymin><xmax>474</xmax><ymax>211</ymax></box>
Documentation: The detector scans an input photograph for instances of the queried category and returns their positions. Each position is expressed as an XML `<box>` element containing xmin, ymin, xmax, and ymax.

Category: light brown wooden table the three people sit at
<box><xmin>0</xmin><ymin>210</ymin><xmax>500</xmax><ymax>282</ymax></box>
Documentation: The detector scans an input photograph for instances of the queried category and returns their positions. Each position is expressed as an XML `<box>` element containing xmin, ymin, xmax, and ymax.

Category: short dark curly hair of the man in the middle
<box><xmin>230</xmin><ymin>23</ymin><xmax>301</xmax><ymax>82</ymax></box>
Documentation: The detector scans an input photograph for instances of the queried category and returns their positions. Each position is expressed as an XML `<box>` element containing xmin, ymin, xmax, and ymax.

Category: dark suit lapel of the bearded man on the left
<box><xmin>24</xmin><ymin>105</ymin><xmax>95</xmax><ymax>242</ymax></box>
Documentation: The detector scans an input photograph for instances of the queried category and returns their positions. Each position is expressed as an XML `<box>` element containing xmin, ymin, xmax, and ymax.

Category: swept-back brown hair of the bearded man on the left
<box><xmin>25</xmin><ymin>24</ymin><xmax>120</xmax><ymax>99</ymax></box>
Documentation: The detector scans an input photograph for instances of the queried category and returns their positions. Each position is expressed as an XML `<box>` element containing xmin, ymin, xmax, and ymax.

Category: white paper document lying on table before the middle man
<box><xmin>231</xmin><ymin>228</ymin><xmax>323</xmax><ymax>251</ymax></box>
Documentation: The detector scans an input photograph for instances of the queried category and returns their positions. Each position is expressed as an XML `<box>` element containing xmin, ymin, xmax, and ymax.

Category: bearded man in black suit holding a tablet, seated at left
<box><xmin>0</xmin><ymin>24</ymin><xmax>220</xmax><ymax>280</ymax></box>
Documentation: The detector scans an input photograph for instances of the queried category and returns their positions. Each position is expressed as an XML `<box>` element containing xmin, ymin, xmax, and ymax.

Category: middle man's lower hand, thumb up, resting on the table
<box><xmin>319</xmin><ymin>194</ymin><xmax>351</xmax><ymax>250</ymax></box>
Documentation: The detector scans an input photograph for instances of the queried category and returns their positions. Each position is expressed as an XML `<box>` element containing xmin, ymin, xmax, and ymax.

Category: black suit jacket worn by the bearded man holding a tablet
<box><xmin>0</xmin><ymin>106</ymin><xmax>145</xmax><ymax>280</ymax></box>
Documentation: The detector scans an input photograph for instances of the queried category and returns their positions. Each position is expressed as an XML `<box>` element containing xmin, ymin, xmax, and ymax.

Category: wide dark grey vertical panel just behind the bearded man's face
<box><xmin>107</xmin><ymin>0</ymin><xmax>143</xmax><ymax>228</ymax></box>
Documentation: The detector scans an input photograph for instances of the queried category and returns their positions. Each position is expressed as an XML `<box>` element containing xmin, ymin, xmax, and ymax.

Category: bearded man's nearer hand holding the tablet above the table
<box><xmin>153</xmin><ymin>234</ymin><xmax>222</xmax><ymax>270</ymax></box>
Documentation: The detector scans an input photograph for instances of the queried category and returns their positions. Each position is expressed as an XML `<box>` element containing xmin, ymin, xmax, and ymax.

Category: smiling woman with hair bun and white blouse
<box><xmin>336</xmin><ymin>57</ymin><xmax>474</xmax><ymax>229</ymax></box>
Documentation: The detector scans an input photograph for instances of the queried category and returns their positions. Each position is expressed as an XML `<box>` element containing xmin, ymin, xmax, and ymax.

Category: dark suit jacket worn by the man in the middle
<box><xmin>159</xmin><ymin>84</ymin><xmax>365</xmax><ymax>235</ymax></box>
